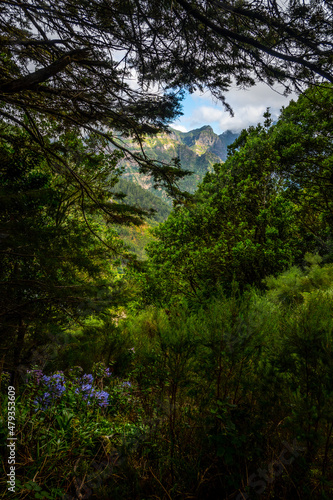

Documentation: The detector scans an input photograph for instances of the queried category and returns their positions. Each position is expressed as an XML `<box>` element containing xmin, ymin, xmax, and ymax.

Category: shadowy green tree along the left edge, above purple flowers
<box><xmin>0</xmin><ymin>124</ymin><xmax>132</xmax><ymax>377</ymax></box>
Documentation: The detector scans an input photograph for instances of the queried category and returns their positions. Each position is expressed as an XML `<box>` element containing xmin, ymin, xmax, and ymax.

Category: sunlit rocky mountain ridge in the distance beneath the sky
<box><xmin>115</xmin><ymin>125</ymin><xmax>239</xmax><ymax>204</ymax></box>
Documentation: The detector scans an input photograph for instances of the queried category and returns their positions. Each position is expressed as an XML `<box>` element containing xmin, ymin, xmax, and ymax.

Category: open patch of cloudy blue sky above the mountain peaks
<box><xmin>171</xmin><ymin>83</ymin><xmax>296</xmax><ymax>134</ymax></box>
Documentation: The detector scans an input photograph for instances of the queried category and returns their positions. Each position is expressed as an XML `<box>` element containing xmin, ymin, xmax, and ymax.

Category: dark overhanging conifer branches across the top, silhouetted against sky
<box><xmin>0</xmin><ymin>0</ymin><xmax>333</xmax><ymax>199</ymax></box>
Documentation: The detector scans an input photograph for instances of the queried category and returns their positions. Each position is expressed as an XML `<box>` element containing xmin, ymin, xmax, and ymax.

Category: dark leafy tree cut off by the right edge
<box><xmin>273</xmin><ymin>85</ymin><xmax>333</xmax><ymax>240</ymax></box>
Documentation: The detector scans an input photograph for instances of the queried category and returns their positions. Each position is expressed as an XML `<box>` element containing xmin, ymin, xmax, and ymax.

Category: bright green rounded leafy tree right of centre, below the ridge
<box><xmin>148</xmin><ymin>107</ymin><xmax>327</xmax><ymax>300</ymax></box>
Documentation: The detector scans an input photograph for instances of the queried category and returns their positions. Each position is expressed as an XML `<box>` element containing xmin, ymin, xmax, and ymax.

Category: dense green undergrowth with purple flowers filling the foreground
<box><xmin>2</xmin><ymin>256</ymin><xmax>333</xmax><ymax>500</ymax></box>
